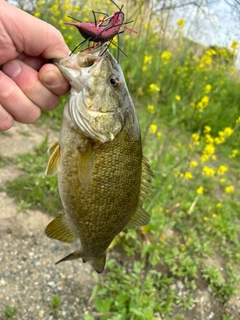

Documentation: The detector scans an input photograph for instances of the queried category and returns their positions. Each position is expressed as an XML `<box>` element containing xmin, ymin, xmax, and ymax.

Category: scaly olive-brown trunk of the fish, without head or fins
<box><xmin>58</xmin><ymin>115</ymin><xmax>142</xmax><ymax>260</ymax></box>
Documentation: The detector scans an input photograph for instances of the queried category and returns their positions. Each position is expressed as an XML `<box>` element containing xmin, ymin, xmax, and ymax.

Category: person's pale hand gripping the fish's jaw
<box><xmin>0</xmin><ymin>0</ymin><xmax>70</xmax><ymax>131</ymax></box>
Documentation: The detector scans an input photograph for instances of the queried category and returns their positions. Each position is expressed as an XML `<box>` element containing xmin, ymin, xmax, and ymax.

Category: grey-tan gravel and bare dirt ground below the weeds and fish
<box><xmin>0</xmin><ymin>124</ymin><xmax>240</xmax><ymax>320</ymax></box>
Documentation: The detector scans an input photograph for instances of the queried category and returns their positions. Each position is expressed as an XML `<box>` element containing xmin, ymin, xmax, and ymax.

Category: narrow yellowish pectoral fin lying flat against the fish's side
<box><xmin>78</xmin><ymin>142</ymin><xmax>93</xmax><ymax>188</ymax></box>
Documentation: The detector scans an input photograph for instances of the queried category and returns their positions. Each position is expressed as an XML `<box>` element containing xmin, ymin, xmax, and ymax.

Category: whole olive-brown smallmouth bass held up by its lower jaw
<box><xmin>45</xmin><ymin>50</ymin><xmax>154</xmax><ymax>273</ymax></box>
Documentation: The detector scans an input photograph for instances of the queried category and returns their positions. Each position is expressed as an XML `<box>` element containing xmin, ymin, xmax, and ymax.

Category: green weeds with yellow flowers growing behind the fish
<box><xmin>3</xmin><ymin>0</ymin><xmax>240</xmax><ymax>320</ymax></box>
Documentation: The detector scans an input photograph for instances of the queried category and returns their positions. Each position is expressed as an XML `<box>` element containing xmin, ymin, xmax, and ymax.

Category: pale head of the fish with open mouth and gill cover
<box><xmin>57</xmin><ymin>47</ymin><xmax>140</xmax><ymax>142</ymax></box>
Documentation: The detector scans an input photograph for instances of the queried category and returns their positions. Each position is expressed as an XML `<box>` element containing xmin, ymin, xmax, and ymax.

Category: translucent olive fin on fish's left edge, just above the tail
<box><xmin>45</xmin><ymin>211</ymin><xmax>77</xmax><ymax>243</ymax></box>
